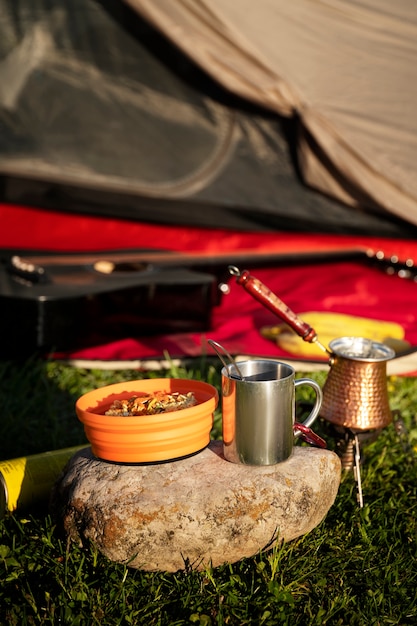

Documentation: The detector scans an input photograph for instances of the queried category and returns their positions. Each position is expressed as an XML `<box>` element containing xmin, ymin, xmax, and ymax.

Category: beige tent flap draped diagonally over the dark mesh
<box><xmin>126</xmin><ymin>0</ymin><xmax>417</xmax><ymax>224</ymax></box>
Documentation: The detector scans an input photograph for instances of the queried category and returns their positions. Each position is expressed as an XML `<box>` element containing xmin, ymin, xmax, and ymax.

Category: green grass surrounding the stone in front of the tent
<box><xmin>0</xmin><ymin>359</ymin><xmax>417</xmax><ymax>626</ymax></box>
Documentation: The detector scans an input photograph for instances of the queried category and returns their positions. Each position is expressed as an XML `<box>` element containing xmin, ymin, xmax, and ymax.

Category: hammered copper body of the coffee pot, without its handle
<box><xmin>320</xmin><ymin>337</ymin><xmax>395</xmax><ymax>431</ymax></box>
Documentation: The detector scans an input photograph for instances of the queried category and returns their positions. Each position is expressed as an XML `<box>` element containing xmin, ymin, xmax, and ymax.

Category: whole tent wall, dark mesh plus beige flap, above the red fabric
<box><xmin>0</xmin><ymin>0</ymin><xmax>417</xmax><ymax>238</ymax></box>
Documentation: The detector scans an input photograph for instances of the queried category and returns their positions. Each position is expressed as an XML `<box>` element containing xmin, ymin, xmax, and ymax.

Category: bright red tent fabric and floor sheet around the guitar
<box><xmin>0</xmin><ymin>204</ymin><xmax>417</xmax><ymax>360</ymax></box>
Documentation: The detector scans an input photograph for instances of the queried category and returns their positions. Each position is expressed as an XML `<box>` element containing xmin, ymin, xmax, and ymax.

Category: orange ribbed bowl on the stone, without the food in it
<box><xmin>75</xmin><ymin>378</ymin><xmax>219</xmax><ymax>463</ymax></box>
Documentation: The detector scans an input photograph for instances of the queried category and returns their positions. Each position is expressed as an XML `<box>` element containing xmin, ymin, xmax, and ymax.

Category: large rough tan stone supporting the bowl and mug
<box><xmin>52</xmin><ymin>441</ymin><xmax>341</xmax><ymax>572</ymax></box>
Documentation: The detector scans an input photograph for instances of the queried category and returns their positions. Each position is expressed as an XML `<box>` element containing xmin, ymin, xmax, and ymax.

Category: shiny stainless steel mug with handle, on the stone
<box><xmin>221</xmin><ymin>359</ymin><xmax>322</xmax><ymax>465</ymax></box>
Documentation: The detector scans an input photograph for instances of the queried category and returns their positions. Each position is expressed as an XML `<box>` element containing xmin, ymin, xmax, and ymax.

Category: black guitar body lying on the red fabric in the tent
<box><xmin>0</xmin><ymin>250</ymin><xmax>219</xmax><ymax>357</ymax></box>
